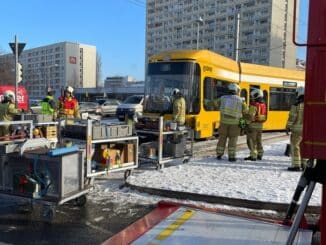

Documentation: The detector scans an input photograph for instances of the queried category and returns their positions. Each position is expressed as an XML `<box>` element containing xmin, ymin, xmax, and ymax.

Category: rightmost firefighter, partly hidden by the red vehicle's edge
<box><xmin>286</xmin><ymin>87</ymin><xmax>306</xmax><ymax>171</ymax></box>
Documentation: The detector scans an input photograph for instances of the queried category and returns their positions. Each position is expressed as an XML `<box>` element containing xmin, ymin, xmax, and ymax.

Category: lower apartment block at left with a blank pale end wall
<box><xmin>0</xmin><ymin>42</ymin><xmax>96</xmax><ymax>98</ymax></box>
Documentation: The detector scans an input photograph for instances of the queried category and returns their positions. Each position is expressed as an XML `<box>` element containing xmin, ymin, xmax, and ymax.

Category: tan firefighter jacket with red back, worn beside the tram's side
<box><xmin>245</xmin><ymin>101</ymin><xmax>267</xmax><ymax>129</ymax></box>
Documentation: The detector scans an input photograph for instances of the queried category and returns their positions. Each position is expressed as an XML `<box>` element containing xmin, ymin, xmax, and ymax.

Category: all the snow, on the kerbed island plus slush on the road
<box><xmin>88</xmin><ymin>141</ymin><xmax>321</xmax><ymax>214</ymax></box>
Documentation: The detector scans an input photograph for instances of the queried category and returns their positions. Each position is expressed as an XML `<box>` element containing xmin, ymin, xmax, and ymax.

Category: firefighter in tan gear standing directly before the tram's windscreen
<box><xmin>172</xmin><ymin>88</ymin><xmax>186</xmax><ymax>126</ymax></box>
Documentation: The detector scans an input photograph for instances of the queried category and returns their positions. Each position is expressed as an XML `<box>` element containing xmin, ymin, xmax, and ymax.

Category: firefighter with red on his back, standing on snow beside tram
<box><xmin>244</xmin><ymin>89</ymin><xmax>267</xmax><ymax>161</ymax></box>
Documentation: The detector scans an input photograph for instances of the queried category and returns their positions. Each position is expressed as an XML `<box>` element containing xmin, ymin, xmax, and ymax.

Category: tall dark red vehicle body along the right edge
<box><xmin>293</xmin><ymin>0</ymin><xmax>326</xmax><ymax>244</ymax></box>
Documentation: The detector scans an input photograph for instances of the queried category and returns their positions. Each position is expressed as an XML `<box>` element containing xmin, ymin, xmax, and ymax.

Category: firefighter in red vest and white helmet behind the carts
<box><xmin>59</xmin><ymin>86</ymin><xmax>80</xmax><ymax>124</ymax></box>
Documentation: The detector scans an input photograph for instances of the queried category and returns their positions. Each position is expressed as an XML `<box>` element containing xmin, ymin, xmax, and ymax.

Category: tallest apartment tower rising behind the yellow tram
<box><xmin>146</xmin><ymin>0</ymin><xmax>296</xmax><ymax>69</ymax></box>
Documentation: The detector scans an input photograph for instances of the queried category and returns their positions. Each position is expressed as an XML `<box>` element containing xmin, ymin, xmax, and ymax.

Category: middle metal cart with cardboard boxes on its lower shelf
<box><xmin>63</xmin><ymin>119</ymin><xmax>138</xmax><ymax>179</ymax></box>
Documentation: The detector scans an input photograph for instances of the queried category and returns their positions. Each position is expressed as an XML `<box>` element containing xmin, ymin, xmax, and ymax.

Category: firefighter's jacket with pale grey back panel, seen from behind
<box><xmin>214</xmin><ymin>95</ymin><xmax>248</xmax><ymax>125</ymax></box>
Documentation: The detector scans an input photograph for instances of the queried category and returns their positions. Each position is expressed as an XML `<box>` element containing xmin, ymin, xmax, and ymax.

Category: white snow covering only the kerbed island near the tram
<box><xmin>127</xmin><ymin>141</ymin><xmax>321</xmax><ymax>205</ymax></box>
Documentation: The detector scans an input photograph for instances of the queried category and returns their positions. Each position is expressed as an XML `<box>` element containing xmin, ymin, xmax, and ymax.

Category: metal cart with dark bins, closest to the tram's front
<box><xmin>136</xmin><ymin>116</ymin><xmax>194</xmax><ymax>169</ymax></box>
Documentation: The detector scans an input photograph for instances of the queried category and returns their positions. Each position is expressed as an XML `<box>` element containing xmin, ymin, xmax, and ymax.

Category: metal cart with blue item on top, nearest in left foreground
<box><xmin>0</xmin><ymin>121</ymin><xmax>90</xmax><ymax>221</ymax></box>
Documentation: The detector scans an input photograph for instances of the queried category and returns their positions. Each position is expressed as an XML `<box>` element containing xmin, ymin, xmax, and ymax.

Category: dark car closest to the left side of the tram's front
<box><xmin>116</xmin><ymin>95</ymin><xmax>144</xmax><ymax>121</ymax></box>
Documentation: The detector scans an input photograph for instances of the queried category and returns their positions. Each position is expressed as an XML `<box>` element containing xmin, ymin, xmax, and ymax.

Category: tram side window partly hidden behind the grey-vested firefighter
<box><xmin>204</xmin><ymin>77</ymin><xmax>229</xmax><ymax>111</ymax></box>
